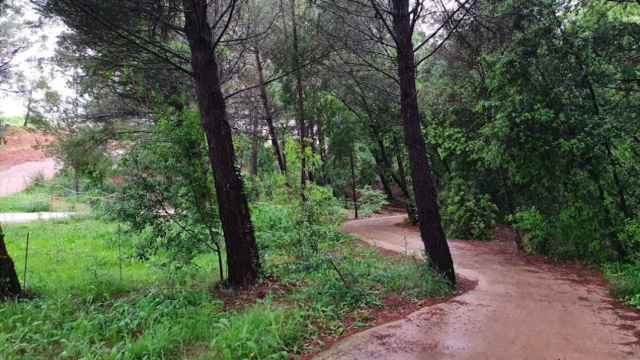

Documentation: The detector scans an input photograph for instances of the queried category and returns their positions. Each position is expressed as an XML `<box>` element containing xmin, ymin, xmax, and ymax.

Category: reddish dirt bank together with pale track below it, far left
<box><xmin>0</xmin><ymin>128</ymin><xmax>58</xmax><ymax>196</ymax></box>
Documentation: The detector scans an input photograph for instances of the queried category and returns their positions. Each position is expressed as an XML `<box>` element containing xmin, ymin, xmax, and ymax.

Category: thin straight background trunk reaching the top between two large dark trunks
<box><xmin>289</xmin><ymin>0</ymin><xmax>307</xmax><ymax>201</ymax></box>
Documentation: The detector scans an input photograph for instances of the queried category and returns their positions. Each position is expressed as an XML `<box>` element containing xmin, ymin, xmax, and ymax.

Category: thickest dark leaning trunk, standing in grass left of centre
<box><xmin>183</xmin><ymin>0</ymin><xmax>260</xmax><ymax>287</ymax></box>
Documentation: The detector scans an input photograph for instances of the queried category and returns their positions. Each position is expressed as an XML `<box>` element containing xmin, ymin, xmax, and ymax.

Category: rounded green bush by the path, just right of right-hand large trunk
<box><xmin>441</xmin><ymin>179</ymin><xmax>498</xmax><ymax>240</ymax></box>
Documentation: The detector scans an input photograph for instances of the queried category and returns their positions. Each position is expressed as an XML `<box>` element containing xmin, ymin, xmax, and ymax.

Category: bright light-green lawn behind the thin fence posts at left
<box><xmin>4</xmin><ymin>219</ymin><xmax>155</xmax><ymax>298</ymax></box>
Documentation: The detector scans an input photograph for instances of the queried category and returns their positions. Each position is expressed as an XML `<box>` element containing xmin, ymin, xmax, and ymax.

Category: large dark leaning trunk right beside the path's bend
<box><xmin>393</xmin><ymin>0</ymin><xmax>456</xmax><ymax>285</ymax></box>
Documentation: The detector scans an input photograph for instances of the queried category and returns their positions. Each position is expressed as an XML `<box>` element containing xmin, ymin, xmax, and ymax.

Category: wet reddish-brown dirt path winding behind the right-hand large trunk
<box><xmin>316</xmin><ymin>216</ymin><xmax>640</xmax><ymax>360</ymax></box>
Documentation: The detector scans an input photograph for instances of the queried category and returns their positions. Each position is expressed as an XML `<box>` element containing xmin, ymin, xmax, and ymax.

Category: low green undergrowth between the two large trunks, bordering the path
<box><xmin>252</xmin><ymin>186</ymin><xmax>449</xmax><ymax>320</ymax></box>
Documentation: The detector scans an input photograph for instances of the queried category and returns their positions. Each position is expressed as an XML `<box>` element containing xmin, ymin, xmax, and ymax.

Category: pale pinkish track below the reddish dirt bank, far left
<box><xmin>0</xmin><ymin>159</ymin><xmax>58</xmax><ymax>197</ymax></box>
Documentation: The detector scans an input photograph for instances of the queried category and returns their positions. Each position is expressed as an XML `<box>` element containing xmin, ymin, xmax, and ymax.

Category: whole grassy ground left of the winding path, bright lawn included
<box><xmin>0</xmin><ymin>215</ymin><xmax>449</xmax><ymax>360</ymax></box>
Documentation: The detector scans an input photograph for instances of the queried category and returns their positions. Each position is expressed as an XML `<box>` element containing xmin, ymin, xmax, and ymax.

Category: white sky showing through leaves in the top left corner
<box><xmin>0</xmin><ymin>0</ymin><xmax>71</xmax><ymax>116</ymax></box>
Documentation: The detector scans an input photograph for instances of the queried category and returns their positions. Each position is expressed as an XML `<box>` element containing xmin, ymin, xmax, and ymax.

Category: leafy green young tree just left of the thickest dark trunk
<box><xmin>103</xmin><ymin>108</ymin><xmax>222</xmax><ymax>266</ymax></box>
